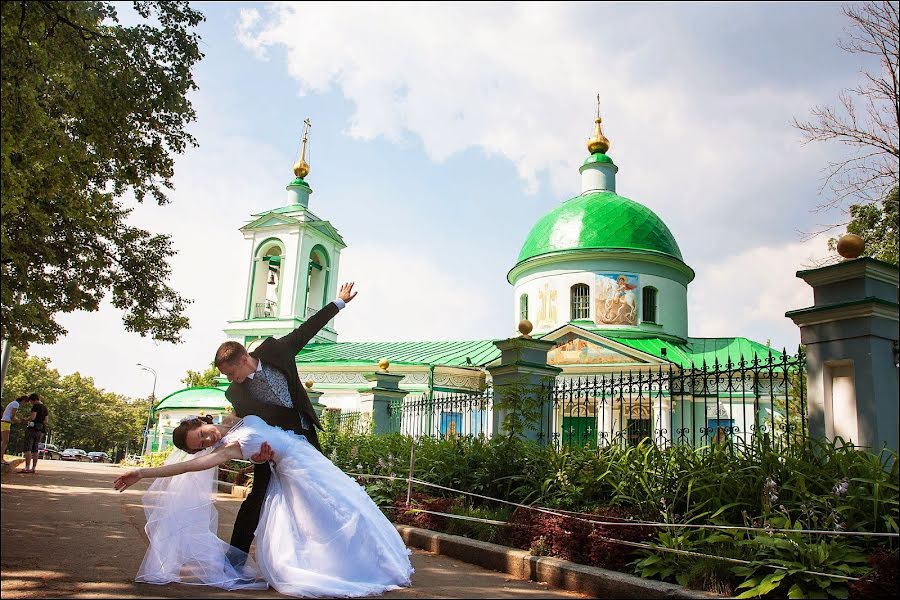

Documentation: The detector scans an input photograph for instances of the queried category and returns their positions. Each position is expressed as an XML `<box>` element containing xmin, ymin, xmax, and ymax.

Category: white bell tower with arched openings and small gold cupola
<box><xmin>224</xmin><ymin>119</ymin><xmax>347</xmax><ymax>350</ymax></box>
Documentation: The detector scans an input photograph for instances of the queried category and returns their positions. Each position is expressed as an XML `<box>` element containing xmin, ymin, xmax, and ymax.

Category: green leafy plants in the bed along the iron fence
<box><xmin>323</xmin><ymin>433</ymin><xmax>900</xmax><ymax>597</ymax></box>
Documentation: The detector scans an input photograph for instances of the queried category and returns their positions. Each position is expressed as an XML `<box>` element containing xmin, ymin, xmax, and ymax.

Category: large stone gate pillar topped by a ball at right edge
<box><xmin>785</xmin><ymin>238</ymin><xmax>900</xmax><ymax>453</ymax></box>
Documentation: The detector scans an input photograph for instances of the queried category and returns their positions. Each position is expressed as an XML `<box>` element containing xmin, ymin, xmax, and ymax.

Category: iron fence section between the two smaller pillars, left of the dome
<box><xmin>388</xmin><ymin>388</ymin><xmax>494</xmax><ymax>438</ymax></box>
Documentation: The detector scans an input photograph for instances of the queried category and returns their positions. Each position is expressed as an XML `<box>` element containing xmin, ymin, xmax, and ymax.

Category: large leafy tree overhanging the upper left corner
<box><xmin>0</xmin><ymin>0</ymin><xmax>203</xmax><ymax>347</ymax></box>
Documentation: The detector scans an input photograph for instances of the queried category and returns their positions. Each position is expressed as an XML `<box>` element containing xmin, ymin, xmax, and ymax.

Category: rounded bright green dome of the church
<box><xmin>518</xmin><ymin>191</ymin><xmax>683</xmax><ymax>263</ymax></box>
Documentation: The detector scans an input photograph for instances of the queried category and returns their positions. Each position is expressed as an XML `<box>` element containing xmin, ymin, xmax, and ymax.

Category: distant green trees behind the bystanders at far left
<box><xmin>3</xmin><ymin>348</ymin><xmax>150</xmax><ymax>452</ymax></box>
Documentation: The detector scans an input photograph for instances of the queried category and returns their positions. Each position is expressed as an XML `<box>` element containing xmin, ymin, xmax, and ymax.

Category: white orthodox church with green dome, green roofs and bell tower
<box><xmin>146</xmin><ymin>108</ymin><xmax>769</xmax><ymax>447</ymax></box>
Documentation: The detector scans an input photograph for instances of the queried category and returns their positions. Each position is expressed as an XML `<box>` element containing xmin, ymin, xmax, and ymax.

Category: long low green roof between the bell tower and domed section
<box><xmin>296</xmin><ymin>340</ymin><xmax>500</xmax><ymax>368</ymax></box>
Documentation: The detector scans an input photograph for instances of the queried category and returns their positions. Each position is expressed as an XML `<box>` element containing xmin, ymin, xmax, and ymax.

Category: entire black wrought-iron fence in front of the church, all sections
<box><xmin>324</xmin><ymin>352</ymin><xmax>807</xmax><ymax>447</ymax></box>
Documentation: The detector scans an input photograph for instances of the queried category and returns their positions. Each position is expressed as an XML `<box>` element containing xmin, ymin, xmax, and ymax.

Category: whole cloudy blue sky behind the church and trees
<box><xmin>32</xmin><ymin>2</ymin><xmax>872</xmax><ymax>397</ymax></box>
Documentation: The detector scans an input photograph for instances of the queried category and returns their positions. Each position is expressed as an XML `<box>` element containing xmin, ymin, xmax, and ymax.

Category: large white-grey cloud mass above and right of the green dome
<box><xmin>232</xmin><ymin>3</ymin><xmax>856</xmax><ymax>354</ymax></box>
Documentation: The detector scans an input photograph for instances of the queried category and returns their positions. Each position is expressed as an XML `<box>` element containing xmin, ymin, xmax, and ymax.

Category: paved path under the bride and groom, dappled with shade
<box><xmin>0</xmin><ymin>460</ymin><xmax>586</xmax><ymax>599</ymax></box>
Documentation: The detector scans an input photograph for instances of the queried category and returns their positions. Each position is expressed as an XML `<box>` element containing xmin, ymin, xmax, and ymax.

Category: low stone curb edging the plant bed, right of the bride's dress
<box><xmin>394</xmin><ymin>524</ymin><xmax>722</xmax><ymax>600</ymax></box>
